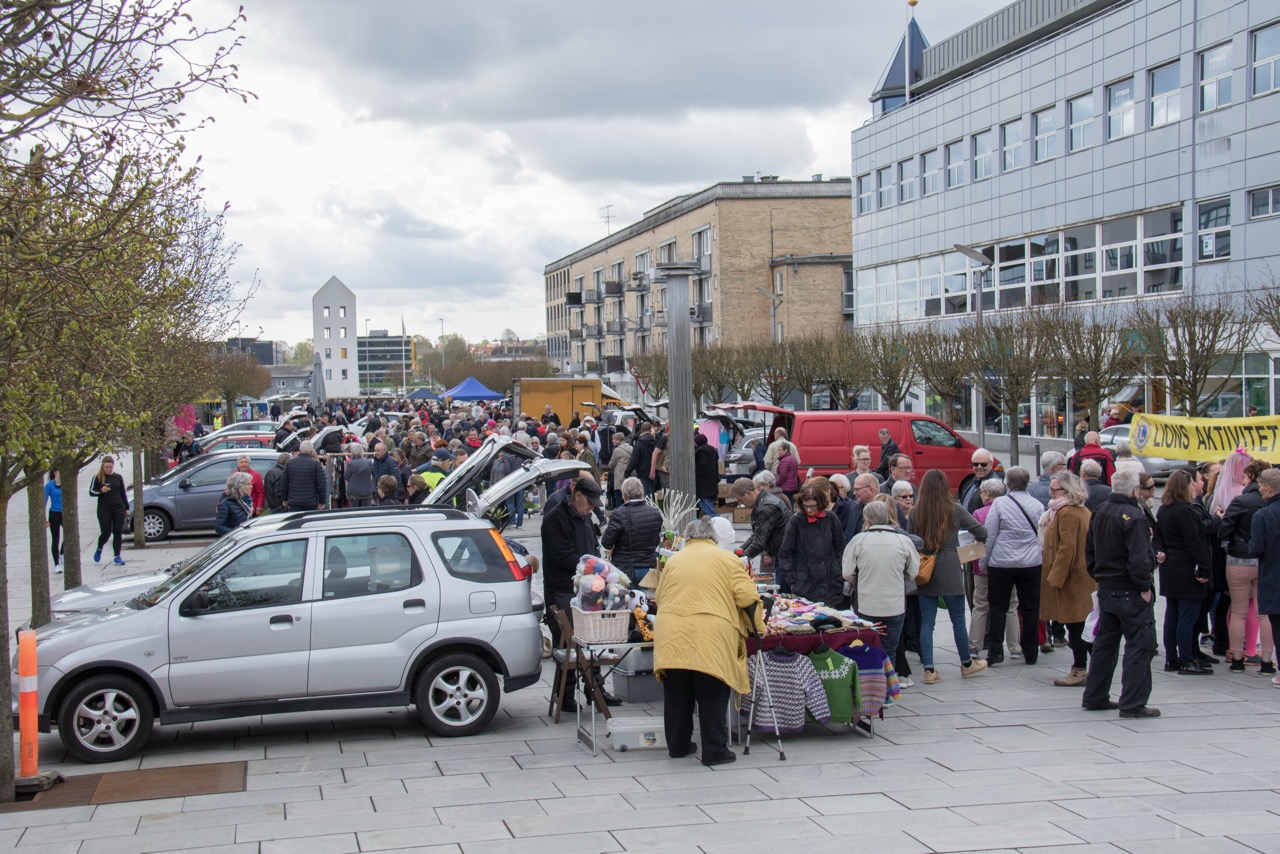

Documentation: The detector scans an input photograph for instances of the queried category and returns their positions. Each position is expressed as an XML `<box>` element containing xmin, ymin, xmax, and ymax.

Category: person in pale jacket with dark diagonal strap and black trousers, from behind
<box><xmin>983</xmin><ymin>466</ymin><xmax>1043</xmax><ymax>665</ymax></box>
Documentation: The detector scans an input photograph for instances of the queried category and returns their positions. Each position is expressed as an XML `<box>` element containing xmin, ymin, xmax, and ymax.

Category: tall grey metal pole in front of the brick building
<box><xmin>658</xmin><ymin>264</ymin><xmax>699</xmax><ymax>525</ymax></box>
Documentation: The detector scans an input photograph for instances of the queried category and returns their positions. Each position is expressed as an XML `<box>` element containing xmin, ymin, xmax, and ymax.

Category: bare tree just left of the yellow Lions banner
<box><xmin>1044</xmin><ymin>303</ymin><xmax>1143</xmax><ymax>424</ymax></box>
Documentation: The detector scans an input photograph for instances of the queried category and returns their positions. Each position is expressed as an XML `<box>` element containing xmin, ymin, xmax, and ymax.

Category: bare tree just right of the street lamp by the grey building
<box><xmin>969</xmin><ymin>307</ymin><xmax>1051</xmax><ymax>465</ymax></box>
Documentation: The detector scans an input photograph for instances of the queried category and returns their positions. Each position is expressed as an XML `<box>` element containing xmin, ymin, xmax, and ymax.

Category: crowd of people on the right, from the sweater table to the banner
<box><xmin>731</xmin><ymin>430</ymin><xmax>1280</xmax><ymax>718</ymax></box>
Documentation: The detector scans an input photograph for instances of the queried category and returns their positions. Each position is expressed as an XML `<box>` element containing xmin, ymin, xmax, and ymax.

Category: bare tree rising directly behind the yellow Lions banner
<box><xmin>1133</xmin><ymin>291</ymin><xmax>1253</xmax><ymax>417</ymax></box>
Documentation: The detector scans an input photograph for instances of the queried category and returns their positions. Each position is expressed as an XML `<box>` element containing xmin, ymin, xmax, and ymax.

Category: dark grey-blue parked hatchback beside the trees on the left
<box><xmin>142</xmin><ymin>448</ymin><xmax>280</xmax><ymax>543</ymax></box>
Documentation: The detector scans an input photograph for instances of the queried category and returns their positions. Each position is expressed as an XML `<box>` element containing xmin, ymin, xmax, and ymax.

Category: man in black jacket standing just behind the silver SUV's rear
<box><xmin>541</xmin><ymin>478</ymin><xmax>621</xmax><ymax>712</ymax></box>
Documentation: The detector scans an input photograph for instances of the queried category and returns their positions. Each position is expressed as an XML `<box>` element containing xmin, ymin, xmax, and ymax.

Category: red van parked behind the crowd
<box><xmin>731</xmin><ymin>403</ymin><xmax>1000</xmax><ymax>489</ymax></box>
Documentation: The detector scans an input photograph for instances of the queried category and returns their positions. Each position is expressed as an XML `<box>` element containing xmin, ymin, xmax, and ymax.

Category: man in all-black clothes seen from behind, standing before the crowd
<box><xmin>1082</xmin><ymin>471</ymin><xmax>1160</xmax><ymax>718</ymax></box>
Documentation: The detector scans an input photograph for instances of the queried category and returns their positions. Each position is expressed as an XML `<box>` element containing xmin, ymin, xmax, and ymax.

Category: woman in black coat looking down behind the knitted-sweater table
<box><xmin>778</xmin><ymin>483</ymin><xmax>845</xmax><ymax>607</ymax></box>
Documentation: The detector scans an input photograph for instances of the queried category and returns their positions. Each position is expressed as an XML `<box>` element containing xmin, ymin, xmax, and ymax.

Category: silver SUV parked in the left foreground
<box><xmin>13</xmin><ymin>501</ymin><xmax>541</xmax><ymax>762</ymax></box>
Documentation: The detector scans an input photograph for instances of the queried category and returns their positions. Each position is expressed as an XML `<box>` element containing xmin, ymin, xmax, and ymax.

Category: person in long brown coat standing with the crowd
<box><xmin>1041</xmin><ymin>471</ymin><xmax>1098</xmax><ymax>688</ymax></box>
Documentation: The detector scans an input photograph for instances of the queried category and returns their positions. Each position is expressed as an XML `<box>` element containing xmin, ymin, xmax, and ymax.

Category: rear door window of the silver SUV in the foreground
<box><xmin>321</xmin><ymin>534</ymin><xmax>422</xmax><ymax>599</ymax></box>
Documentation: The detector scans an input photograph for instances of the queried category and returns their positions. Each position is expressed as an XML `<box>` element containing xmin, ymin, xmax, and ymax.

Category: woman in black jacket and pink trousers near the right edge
<box><xmin>1215</xmin><ymin>460</ymin><xmax>1276</xmax><ymax>676</ymax></box>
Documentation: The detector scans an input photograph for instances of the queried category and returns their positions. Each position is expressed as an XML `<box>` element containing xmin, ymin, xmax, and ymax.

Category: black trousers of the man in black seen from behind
<box><xmin>1083</xmin><ymin>590</ymin><xmax>1156</xmax><ymax>711</ymax></box>
